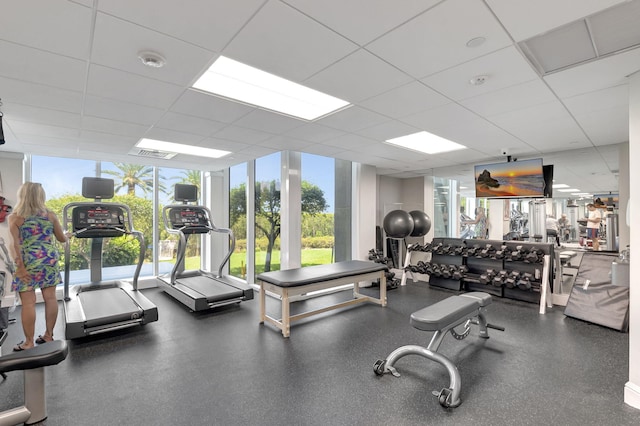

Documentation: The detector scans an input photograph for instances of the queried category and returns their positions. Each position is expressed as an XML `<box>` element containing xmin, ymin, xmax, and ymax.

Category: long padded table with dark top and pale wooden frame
<box><xmin>257</xmin><ymin>260</ymin><xmax>388</xmax><ymax>337</ymax></box>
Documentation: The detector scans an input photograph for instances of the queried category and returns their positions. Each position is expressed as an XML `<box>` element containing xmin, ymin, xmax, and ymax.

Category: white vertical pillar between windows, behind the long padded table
<box><xmin>280</xmin><ymin>151</ymin><xmax>302</xmax><ymax>269</ymax></box>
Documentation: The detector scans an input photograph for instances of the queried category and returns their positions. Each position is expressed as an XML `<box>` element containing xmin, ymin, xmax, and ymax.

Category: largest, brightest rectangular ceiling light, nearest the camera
<box><xmin>193</xmin><ymin>56</ymin><xmax>349</xmax><ymax>120</ymax></box>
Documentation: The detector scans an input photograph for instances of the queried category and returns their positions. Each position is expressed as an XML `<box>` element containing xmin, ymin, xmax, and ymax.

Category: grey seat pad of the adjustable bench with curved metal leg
<box><xmin>410</xmin><ymin>291</ymin><xmax>491</xmax><ymax>331</ymax></box>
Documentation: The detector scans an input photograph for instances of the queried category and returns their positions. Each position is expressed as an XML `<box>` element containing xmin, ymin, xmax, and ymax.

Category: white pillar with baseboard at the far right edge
<box><xmin>624</xmin><ymin>71</ymin><xmax>640</xmax><ymax>409</ymax></box>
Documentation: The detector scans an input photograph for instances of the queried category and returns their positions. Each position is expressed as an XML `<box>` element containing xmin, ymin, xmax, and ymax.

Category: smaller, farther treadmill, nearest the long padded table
<box><xmin>158</xmin><ymin>184</ymin><xmax>253</xmax><ymax>311</ymax></box>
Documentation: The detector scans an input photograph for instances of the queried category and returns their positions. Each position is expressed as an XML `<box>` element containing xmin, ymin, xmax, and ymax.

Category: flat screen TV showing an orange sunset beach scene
<box><xmin>474</xmin><ymin>158</ymin><xmax>545</xmax><ymax>198</ymax></box>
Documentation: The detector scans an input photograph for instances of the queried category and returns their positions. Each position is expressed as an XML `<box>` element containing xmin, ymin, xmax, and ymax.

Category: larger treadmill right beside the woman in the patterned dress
<box><xmin>62</xmin><ymin>177</ymin><xmax>158</xmax><ymax>339</ymax></box>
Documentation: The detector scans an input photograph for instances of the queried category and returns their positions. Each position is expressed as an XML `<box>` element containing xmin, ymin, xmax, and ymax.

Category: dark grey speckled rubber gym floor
<box><xmin>0</xmin><ymin>282</ymin><xmax>640</xmax><ymax>426</ymax></box>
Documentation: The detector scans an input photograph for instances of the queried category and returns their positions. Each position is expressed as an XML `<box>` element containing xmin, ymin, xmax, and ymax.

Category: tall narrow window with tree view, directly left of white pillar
<box><xmin>254</xmin><ymin>153</ymin><xmax>281</xmax><ymax>274</ymax></box>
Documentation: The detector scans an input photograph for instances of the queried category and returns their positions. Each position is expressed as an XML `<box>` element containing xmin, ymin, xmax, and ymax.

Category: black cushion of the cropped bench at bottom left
<box><xmin>0</xmin><ymin>340</ymin><xmax>69</xmax><ymax>373</ymax></box>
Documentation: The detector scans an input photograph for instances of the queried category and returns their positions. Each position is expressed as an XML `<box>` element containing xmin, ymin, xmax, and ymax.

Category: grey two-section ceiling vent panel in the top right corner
<box><xmin>519</xmin><ymin>1</ymin><xmax>640</xmax><ymax>76</ymax></box>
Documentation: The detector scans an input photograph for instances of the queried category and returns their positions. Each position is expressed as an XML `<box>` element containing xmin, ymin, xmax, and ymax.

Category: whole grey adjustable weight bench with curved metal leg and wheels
<box><xmin>373</xmin><ymin>292</ymin><xmax>504</xmax><ymax>408</ymax></box>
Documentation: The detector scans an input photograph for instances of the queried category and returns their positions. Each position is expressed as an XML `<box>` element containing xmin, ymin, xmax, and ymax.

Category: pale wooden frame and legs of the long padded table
<box><xmin>258</xmin><ymin>270</ymin><xmax>387</xmax><ymax>337</ymax></box>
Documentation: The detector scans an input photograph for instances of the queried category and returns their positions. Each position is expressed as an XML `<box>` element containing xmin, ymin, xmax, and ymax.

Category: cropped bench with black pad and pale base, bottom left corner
<box><xmin>0</xmin><ymin>340</ymin><xmax>69</xmax><ymax>426</ymax></box>
